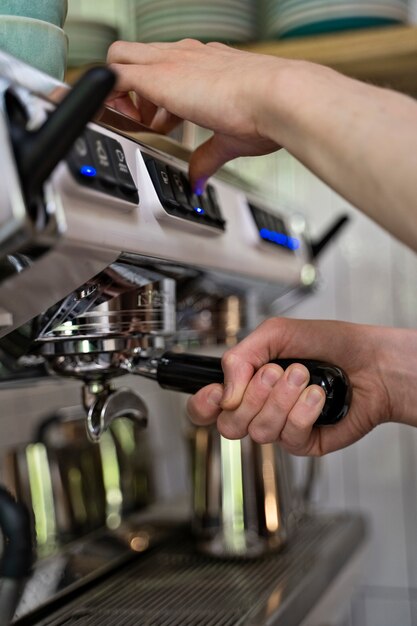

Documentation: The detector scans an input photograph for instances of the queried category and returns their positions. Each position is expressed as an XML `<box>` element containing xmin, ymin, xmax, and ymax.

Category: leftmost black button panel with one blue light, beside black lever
<box><xmin>67</xmin><ymin>129</ymin><xmax>139</xmax><ymax>204</ymax></box>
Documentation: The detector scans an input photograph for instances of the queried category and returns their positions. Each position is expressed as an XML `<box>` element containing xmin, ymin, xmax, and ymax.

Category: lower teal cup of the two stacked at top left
<box><xmin>0</xmin><ymin>15</ymin><xmax>68</xmax><ymax>80</ymax></box>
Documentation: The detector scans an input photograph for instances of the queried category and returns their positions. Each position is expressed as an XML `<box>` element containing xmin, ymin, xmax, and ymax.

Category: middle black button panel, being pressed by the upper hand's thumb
<box><xmin>143</xmin><ymin>154</ymin><xmax>226</xmax><ymax>231</ymax></box>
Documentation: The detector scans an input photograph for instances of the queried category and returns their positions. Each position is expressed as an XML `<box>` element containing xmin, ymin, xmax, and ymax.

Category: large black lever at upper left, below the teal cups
<box><xmin>6</xmin><ymin>67</ymin><xmax>116</xmax><ymax>201</ymax></box>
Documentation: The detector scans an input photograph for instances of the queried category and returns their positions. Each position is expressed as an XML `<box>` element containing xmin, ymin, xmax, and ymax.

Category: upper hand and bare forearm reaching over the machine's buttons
<box><xmin>108</xmin><ymin>39</ymin><xmax>417</xmax><ymax>250</ymax></box>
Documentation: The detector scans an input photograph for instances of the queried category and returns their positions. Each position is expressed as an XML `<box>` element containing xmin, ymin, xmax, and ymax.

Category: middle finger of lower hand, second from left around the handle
<box><xmin>217</xmin><ymin>364</ymin><xmax>284</xmax><ymax>439</ymax></box>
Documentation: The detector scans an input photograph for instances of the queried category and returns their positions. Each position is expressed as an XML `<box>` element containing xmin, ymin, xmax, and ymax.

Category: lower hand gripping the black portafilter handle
<box><xmin>188</xmin><ymin>318</ymin><xmax>417</xmax><ymax>456</ymax></box>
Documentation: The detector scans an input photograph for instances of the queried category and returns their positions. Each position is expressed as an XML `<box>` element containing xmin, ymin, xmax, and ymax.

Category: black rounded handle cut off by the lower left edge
<box><xmin>0</xmin><ymin>487</ymin><xmax>34</xmax><ymax>581</ymax></box>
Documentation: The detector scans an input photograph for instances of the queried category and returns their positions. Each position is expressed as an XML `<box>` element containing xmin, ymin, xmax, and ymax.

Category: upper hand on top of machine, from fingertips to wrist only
<box><xmin>107</xmin><ymin>39</ymin><xmax>282</xmax><ymax>189</ymax></box>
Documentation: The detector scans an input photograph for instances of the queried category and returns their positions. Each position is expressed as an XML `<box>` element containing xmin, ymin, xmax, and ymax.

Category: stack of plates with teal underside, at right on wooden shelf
<box><xmin>263</xmin><ymin>0</ymin><xmax>408</xmax><ymax>39</ymax></box>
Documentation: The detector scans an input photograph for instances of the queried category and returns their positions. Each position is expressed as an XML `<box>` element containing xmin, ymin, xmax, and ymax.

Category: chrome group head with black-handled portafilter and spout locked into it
<box><xmin>35</xmin><ymin>262</ymin><xmax>350</xmax><ymax>441</ymax></box>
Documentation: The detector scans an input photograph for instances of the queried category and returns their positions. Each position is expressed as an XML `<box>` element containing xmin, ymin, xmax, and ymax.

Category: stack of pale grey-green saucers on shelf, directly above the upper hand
<box><xmin>136</xmin><ymin>0</ymin><xmax>256</xmax><ymax>43</ymax></box>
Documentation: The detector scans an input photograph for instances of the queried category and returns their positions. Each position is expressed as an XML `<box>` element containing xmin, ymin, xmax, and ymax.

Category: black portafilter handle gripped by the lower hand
<box><xmin>156</xmin><ymin>352</ymin><xmax>351</xmax><ymax>426</ymax></box>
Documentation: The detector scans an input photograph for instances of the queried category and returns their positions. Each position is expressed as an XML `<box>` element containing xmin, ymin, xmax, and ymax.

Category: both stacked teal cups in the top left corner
<box><xmin>0</xmin><ymin>0</ymin><xmax>68</xmax><ymax>80</ymax></box>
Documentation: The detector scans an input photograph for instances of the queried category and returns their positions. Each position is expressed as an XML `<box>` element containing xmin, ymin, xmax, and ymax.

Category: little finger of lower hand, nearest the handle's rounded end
<box><xmin>279</xmin><ymin>385</ymin><xmax>326</xmax><ymax>455</ymax></box>
